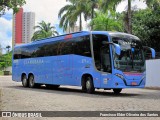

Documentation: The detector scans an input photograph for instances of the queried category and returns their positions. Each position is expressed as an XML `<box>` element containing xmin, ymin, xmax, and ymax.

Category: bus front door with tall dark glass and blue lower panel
<box><xmin>92</xmin><ymin>34</ymin><xmax>112</xmax><ymax>88</ymax></box>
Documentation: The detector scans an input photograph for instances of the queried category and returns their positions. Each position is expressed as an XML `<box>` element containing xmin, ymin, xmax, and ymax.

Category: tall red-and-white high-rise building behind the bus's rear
<box><xmin>12</xmin><ymin>8</ymin><xmax>35</xmax><ymax>46</ymax></box>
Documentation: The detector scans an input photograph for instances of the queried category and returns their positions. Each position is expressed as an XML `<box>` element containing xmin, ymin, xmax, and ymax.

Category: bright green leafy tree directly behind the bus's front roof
<box><xmin>91</xmin><ymin>11</ymin><xmax>123</xmax><ymax>31</ymax></box>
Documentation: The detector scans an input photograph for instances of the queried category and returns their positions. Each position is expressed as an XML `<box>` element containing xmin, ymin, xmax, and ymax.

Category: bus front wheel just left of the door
<box><xmin>86</xmin><ymin>76</ymin><xmax>95</xmax><ymax>94</ymax></box>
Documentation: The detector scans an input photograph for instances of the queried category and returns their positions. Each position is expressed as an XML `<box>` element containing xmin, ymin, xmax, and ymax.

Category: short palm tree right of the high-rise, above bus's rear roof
<box><xmin>32</xmin><ymin>21</ymin><xmax>59</xmax><ymax>41</ymax></box>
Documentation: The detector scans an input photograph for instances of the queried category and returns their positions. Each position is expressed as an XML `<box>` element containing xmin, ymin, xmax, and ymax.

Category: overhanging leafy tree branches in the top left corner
<box><xmin>0</xmin><ymin>0</ymin><xmax>26</xmax><ymax>17</ymax></box>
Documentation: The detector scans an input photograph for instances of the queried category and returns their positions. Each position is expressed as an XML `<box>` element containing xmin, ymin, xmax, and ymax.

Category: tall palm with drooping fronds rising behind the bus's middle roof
<box><xmin>58</xmin><ymin>0</ymin><xmax>97</xmax><ymax>31</ymax></box>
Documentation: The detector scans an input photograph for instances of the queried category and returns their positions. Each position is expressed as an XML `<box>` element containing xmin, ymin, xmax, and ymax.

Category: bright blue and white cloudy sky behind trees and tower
<box><xmin>0</xmin><ymin>0</ymin><xmax>146</xmax><ymax>53</ymax></box>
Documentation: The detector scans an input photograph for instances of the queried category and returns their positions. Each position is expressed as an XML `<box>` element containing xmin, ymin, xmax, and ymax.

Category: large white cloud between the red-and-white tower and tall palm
<box><xmin>23</xmin><ymin>0</ymin><xmax>67</xmax><ymax>24</ymax></box>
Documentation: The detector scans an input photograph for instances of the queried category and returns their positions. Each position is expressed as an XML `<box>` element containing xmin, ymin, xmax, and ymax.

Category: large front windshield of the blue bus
<box><xmin>112</xmin><ymin>35</ymin><xmax>145</xmax><ymax>72</ymax></box>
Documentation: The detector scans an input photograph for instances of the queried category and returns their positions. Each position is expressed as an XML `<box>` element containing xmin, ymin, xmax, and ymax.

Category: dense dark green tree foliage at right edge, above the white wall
<box><xmin>132</xmin><ymin>4</ymin><xmax>160</xmax><ymax>51</ymax></box>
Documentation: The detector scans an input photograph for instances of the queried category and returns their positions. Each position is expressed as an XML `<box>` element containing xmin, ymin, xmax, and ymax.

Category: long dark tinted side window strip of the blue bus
<box><xmin>14</xmin><ymin>36</ymin><xmax>91</xmax><ymax>59</ymax></box>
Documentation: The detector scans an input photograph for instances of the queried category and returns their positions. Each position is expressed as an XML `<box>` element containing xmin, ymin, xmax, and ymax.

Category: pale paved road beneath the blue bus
<box><xmin>0</xmin><ymin>76</ymin><xmax>160</xmax><ymax>120</ymax></box>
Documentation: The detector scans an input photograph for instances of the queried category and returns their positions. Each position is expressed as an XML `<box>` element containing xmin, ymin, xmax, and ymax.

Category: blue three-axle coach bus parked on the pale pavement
<box><xmin>12</xmin><ymin>31</ymin><xmax>155</xmax><ymax>94</ymax></box>
